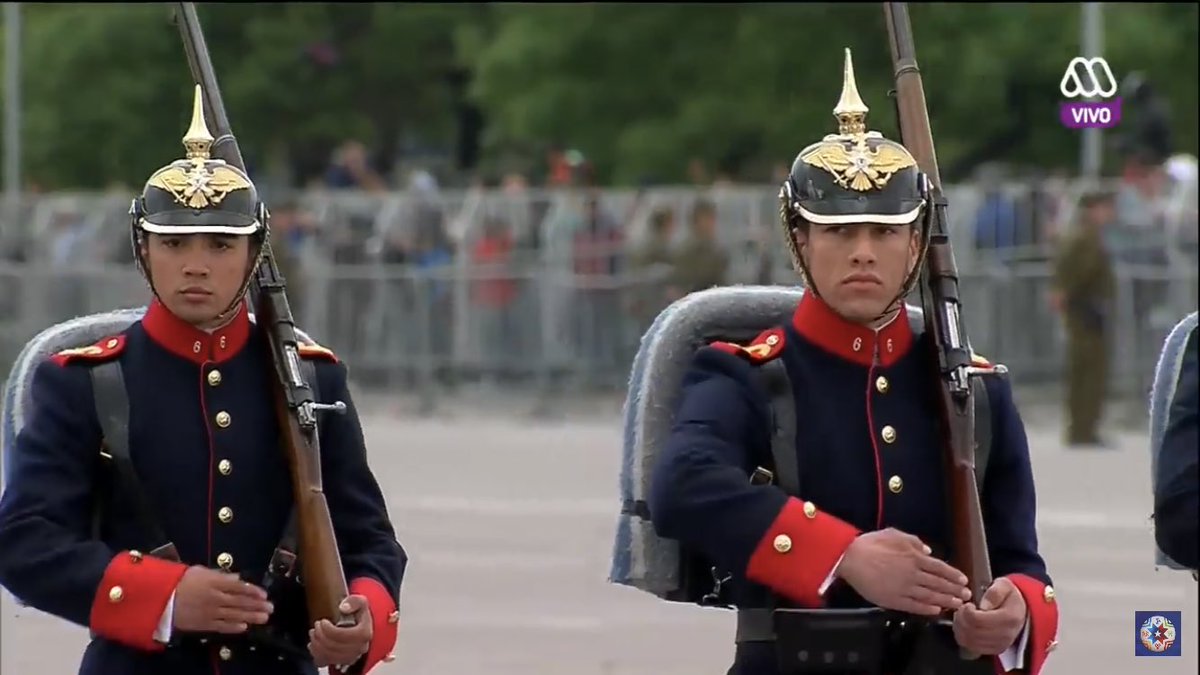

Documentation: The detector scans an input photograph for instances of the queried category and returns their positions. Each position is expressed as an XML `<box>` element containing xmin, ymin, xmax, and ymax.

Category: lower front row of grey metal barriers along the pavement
<box><xmin>0</xmin><ymin>259</ymin><xmax>1198</xmax><ymax>399</ymax></box>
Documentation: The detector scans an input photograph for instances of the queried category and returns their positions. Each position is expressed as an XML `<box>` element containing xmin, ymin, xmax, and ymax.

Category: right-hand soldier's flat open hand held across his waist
<box><xmin>835</xmin><ymin>527</ymin><xmax>971</xmax><ymax>616</ymax></box>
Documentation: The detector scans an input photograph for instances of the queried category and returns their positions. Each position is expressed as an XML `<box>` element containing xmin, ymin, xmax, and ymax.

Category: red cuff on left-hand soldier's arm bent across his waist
<box><xmin>89</xmin><ymin>551</ymin><xmax>187</xmax><ymax>651</ymax></box>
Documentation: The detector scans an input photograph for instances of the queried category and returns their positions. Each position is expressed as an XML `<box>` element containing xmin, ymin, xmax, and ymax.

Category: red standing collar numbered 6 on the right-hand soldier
<box><xmin>792</xmin><ymin>293</ymin><xmax>913</xmax><ymax>366</ymax></box>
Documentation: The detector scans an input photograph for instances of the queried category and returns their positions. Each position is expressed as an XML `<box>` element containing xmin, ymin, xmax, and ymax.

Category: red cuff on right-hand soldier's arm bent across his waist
<box><xmin>745</xmin><ymin>497</ymin><xmax>859</xmax><ymax>607</ymax></box>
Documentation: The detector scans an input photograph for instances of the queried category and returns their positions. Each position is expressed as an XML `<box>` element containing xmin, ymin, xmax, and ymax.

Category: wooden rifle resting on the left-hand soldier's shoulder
<box><xmin>175</xmin><ymin>2</ymin><xmax>354</xmax><ymax>627</ymax></box>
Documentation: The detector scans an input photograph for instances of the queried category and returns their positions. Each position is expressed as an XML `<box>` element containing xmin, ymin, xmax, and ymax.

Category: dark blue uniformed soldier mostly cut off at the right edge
<box><xmin>1154</xmin><ymin>317</ymin><xmax>1200</xmax><ymax>571</ymax></box>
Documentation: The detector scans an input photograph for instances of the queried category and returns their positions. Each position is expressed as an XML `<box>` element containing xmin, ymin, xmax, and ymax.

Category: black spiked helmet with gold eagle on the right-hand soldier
<box><xmin>779</xmin><ymin>48</ymin><xmax>928</xmax><ymax>294</ymax></box>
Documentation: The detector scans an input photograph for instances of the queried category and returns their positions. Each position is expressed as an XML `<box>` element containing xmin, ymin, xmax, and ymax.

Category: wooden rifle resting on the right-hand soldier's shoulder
<box><xmin>883</xmin><ymin>2</ymin><xmax>992</xmax><ymax>607</ymax></box>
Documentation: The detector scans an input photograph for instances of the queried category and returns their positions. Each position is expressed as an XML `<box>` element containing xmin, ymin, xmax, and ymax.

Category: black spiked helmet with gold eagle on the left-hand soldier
<box><xmin>130</xmin><ymin>84</ymin><xmax>269</xmax><ymax>309</ymax></box>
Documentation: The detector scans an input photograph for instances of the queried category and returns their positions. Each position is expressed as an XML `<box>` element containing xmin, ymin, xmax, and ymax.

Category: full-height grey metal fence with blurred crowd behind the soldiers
<box><xmin>0</xmin><ymin>176</ymin><xmax>1198</xmax><ymax>396</ymax></box>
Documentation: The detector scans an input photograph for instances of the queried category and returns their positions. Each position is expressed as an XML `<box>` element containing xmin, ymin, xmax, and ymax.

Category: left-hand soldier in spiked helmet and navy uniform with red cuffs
<box><xmin>0</xmin><ymin>86</ymin><xmax>407</xmax><ymax>675</ymax></box>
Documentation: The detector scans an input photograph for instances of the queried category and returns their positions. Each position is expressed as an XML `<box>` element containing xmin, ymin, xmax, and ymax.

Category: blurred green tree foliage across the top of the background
<box><xmin>0</xmin><ymin>2</ymin><xmax>1198</xmax><ymax>189</ymax></box>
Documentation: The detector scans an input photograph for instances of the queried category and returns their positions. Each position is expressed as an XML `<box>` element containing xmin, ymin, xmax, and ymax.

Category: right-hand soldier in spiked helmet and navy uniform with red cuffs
<box><xmin>648</xmin><ymin>49</ymin><xmax>1058</xmax><ymax>675</ymax></box>
